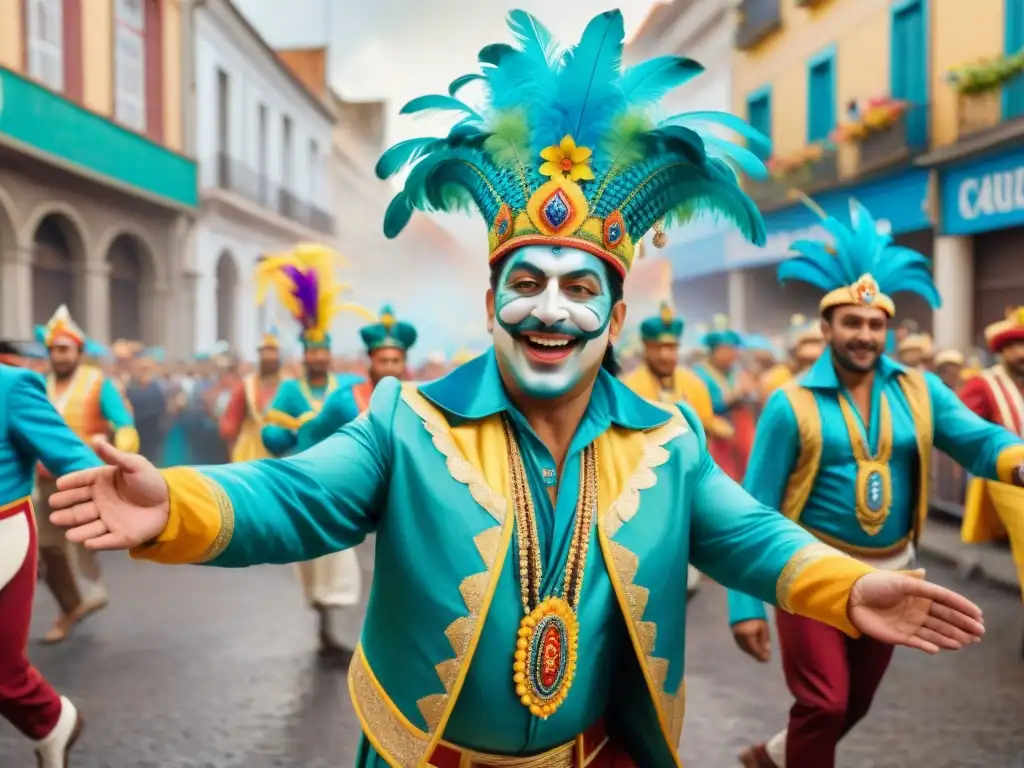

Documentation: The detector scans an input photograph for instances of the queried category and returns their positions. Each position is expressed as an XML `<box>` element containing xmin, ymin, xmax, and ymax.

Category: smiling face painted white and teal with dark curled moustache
<box><xmin>494</xmin><ymin>246</ymin><xmax>612</xmax><ymax>398</ymax></box>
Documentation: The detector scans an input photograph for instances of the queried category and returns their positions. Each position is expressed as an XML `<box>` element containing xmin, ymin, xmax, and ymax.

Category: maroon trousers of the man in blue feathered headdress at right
<box><xmin>775</xmin><ymin>609</ymin><xmax>893</xmax><ymax>768</ymax></box>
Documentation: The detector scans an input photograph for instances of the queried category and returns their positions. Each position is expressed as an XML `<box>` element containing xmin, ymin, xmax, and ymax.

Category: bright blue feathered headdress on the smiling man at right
<box><xmin>778</xmin><ymin>196</ymin><xmax>942</xmax><ymax>317</ymax></box>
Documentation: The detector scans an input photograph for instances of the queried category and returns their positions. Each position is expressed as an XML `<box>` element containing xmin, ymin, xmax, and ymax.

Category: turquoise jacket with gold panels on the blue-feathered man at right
<box><xmin>729</xmin><ymin>351</ymin><xmax>1024</xmax><ymax>624</ymax></box>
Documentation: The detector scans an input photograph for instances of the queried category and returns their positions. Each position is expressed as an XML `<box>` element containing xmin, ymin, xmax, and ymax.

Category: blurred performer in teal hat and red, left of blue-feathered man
<box><xmin>693</xmin><ymin>314</ymin><xmax>757</xmax><ymax>482</ymax></box>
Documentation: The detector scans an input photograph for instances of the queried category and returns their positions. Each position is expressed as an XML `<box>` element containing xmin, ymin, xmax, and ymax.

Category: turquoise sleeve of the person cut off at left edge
<box><xmin>6</xmin><ymin>371</ymin><xmax>102</xmax><ymax>477</ymax></box>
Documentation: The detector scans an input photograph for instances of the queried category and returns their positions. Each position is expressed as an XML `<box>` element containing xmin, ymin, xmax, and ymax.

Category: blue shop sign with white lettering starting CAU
<box><xmin>939</xmin><ymin>147</ymin><xmax>1024</xmax><ymax>234</ymax></box>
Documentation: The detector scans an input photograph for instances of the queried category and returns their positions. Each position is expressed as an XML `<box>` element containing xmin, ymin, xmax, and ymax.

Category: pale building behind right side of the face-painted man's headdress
<box><xmin>627</xmin><ymin>0</ymin><xmax>743</xmax><ymax>335</ymax></box>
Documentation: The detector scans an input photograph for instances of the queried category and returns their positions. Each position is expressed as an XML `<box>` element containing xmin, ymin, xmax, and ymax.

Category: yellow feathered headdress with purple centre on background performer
<box><xmin>256</xmin><ymin>243</ymin><xmax>377</xmax><ymax>348</ymax></box>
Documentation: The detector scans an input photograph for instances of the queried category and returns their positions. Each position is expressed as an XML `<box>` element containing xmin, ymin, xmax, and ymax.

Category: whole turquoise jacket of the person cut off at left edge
<box><xmin>0</xmin><ymin>366</ymin><xmax>102</xmax><ymax>507</ymax></box>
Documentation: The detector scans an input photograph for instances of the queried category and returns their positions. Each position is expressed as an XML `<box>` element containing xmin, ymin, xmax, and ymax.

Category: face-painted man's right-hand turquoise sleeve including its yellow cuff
<box><xmin>687</xmin><ymin>415</ymin><xmax>874</xmax><ymax>637</ymax></box>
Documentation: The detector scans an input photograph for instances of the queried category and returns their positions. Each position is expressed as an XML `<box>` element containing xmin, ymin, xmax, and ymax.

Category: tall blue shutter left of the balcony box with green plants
<box><xmin>889</xmin><ymin>0</ymin><xmax>928</xmax><ymax>148</ymax></box>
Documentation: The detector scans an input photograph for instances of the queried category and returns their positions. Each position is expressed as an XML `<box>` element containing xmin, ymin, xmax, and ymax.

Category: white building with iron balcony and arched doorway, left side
<box><xmin>191</xmin><ymin>0</ymin><xmax>336</xmax><ymax>357</ymax></box>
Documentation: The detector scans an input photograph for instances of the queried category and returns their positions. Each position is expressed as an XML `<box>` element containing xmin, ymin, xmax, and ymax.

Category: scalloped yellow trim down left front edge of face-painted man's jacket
<box><xmin>402</xmin><ymin>384</ymin><xmax>515</xmax><ymax>761</ymax></box>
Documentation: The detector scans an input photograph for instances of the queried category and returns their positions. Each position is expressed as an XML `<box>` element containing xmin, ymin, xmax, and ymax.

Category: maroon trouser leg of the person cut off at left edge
<box><xmin>0</xmin><ymin>501</ymin><xmax>60</xmax><ymax>740</ymax></box>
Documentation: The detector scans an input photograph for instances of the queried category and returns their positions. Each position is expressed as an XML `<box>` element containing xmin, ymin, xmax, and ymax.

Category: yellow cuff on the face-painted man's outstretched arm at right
<box><xmin>775</xmin><ymin>543</ymin><xmax>876</xmax><ymax>637</ymax></box>
